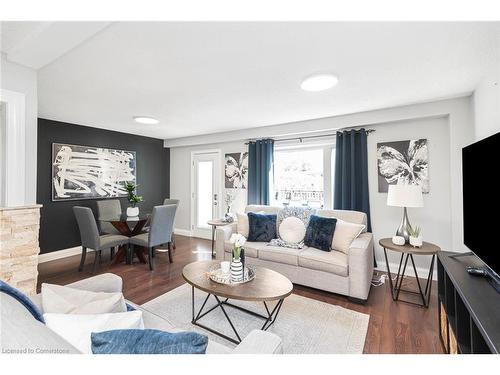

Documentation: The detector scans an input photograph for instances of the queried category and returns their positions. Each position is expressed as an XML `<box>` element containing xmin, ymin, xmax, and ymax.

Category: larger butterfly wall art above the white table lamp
<box><xmin>377</xmin><ymin>139</ymin><xmax>429</xmax><ymax>193</ymax></box>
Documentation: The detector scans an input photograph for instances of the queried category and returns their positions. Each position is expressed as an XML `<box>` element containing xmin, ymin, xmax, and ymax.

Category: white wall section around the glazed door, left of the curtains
<box><xmin>170</xmin><ymin>141</ymin><xmax>248</xmax><ymax>233</ymax></box>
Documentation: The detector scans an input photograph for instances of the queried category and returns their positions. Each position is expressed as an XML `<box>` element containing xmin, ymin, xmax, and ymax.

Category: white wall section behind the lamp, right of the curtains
<box><xmin>368</xmin><ymin>117</ymin><xmax>453</xmax><ymax>272</ymax></box>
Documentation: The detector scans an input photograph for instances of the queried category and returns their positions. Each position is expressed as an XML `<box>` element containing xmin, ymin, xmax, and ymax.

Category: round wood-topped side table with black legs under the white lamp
<box><xmin>379</xmin><ymin>238</ymin><xmax>441</xmax><ymax>308</ymax></box>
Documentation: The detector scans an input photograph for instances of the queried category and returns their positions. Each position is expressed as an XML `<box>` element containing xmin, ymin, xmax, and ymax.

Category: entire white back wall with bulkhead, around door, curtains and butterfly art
<box><xmin>166</xmin><ymin>97</ymin><xmax>474</xmax><ymax>266</ymax></box>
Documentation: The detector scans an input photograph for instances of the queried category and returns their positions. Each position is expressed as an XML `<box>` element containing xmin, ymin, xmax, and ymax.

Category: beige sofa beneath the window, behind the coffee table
<box><xmin>216</xmin><ymin>205</ymin><xmax>373</xmax><ymax>303</ymax></box>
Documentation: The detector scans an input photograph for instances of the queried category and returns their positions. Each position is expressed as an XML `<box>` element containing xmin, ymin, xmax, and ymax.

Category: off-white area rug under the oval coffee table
<box><xmin>143</xmin><ymin>284</ymin><xmax>370</xmax><ymax>354</ymax></box>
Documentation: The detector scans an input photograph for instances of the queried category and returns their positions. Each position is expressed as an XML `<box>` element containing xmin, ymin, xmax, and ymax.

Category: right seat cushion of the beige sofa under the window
<box><xmin>299</xmin><ymin>247</ymin><xmax>348</xmax><ymax>276</ymax></box>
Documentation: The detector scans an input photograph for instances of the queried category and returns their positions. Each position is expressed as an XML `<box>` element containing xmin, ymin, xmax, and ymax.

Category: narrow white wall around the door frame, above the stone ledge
<box><xmin>0</xmin><ymin>54</ymin><xmax>38</xmax><ymax>204</ymax></box>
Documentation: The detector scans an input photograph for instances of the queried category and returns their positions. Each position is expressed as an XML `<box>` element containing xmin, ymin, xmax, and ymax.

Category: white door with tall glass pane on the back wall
<box><xmin>191</xmin><ymin>150</ymin><xmax>222</xmax><ymax>239</ymax></box>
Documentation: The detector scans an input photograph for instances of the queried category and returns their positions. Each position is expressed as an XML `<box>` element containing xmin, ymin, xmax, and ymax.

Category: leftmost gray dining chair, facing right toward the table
<box><xmin>73</xmin><ymin>206</ymin><xmax>129</xmax><ymax>273</ymax></box>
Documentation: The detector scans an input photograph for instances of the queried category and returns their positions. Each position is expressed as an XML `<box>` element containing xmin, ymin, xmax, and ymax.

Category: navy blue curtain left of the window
<box><xmin>248</xmin><ymin>139</ymin><xmax>274</xmax><ymax>204</ymax></box>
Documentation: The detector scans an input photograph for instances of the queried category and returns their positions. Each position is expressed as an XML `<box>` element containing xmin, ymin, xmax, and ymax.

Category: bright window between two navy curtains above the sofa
<box><xmin>272</xmin><ymin>148</ymin><xmax>329</xmax><ymax>208</ymax></box>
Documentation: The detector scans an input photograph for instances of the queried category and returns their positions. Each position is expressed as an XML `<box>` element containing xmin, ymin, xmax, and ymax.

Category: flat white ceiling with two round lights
<box><xmin>2</xmin><ymin>22</ymin><xmax>500</xmax><ymax>138</ymax></box>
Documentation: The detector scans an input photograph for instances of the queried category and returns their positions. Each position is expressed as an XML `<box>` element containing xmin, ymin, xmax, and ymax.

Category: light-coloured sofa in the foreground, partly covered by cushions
<box><xmin>0</xmin><ymin>273</ymin><xmax>283</xmax><ymax>354</ymax></box>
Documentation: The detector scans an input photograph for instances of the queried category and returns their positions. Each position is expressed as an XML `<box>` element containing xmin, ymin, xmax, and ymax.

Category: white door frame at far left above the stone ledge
<box><xmin>0</xmin><ymin>89</ymin><xmax>26</xmax><ymax>207</ymax></box>
